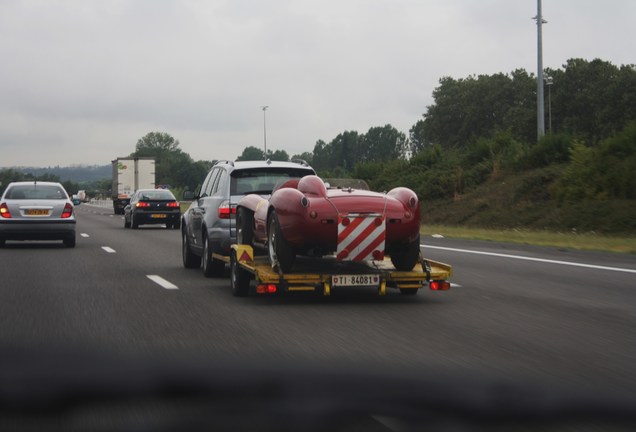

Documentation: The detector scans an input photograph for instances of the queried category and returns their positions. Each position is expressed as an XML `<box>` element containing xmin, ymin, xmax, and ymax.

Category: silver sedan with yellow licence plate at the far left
<box><xmin>0</xmin><ymin>181</ymin><xmax>76</xmax><ymax>248</ymax></box>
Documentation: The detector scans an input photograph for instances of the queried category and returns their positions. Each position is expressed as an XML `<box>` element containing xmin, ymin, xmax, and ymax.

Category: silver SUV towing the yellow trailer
<box><xmin>181</xmin><ymin>160</ymin><xmax>316</xmax><ymax>277</ymax></box>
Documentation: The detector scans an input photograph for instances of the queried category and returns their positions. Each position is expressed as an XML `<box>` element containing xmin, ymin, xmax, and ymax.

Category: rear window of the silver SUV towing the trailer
<box><xmin>230</xmin><ymin>167</ymin><xmax>314</xmax><ymax>195</ymax></box>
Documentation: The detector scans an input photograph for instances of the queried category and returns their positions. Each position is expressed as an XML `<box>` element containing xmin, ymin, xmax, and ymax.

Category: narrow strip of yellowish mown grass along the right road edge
<box><xmin>420</xmin><ymin>225</ymin><xmax>636</xmax><ymax>254</ymax></box>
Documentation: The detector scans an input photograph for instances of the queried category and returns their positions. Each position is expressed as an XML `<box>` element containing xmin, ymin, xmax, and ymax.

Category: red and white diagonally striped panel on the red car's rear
<box><xmin>336</xmin><ymin>213</ymin><xmax>386</xmax><ymax>261</ymax></box>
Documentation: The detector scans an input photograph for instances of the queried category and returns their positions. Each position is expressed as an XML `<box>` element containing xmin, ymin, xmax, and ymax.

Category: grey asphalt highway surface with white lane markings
<box><xmin>0</xmin><ymin>205</ymin><xmax>636</xmax><ymax>428</ymax></box>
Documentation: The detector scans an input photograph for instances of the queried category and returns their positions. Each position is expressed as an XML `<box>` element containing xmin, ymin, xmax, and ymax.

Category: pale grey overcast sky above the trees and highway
<box><xmin>0</xmin><ymin>0</ymin><xmax>636</xmax><ymax>167</ymax></box>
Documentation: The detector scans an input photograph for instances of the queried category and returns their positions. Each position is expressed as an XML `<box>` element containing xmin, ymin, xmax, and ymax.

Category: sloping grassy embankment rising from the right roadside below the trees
<box><xmin>421</xmin><ymin>167</ymin><xmax>636</xmax><ymax>254</ymax></box>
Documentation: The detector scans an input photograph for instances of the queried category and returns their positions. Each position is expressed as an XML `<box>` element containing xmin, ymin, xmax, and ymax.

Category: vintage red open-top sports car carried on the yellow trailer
<box><xmin>237</xmin><ymin>175</ymin><xmax>420</xmax><ymax>272</ymax></box>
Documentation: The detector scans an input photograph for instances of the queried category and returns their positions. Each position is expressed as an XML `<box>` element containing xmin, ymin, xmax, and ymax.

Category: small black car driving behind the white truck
<box><xmin>124</xmin><ymin>189</ymin><xmax>181</xmax><ymax>229</ymax></box>
